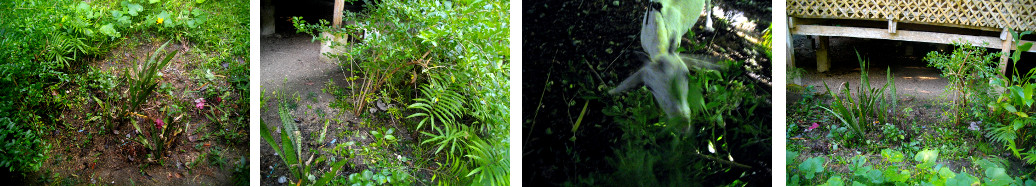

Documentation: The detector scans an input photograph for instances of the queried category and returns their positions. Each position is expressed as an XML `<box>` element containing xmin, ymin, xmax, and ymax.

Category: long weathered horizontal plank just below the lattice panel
<box><xmin>789</xmin><ymin>25</ymin><xmax>1036</xmax><ymax>53</ymax></box>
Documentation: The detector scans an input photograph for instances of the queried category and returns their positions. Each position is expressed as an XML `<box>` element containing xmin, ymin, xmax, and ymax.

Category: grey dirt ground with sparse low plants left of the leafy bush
<box><xmin>260</xmin><ymin>34</ymin><xmax>413</xmax><ymax>185</ymax></box>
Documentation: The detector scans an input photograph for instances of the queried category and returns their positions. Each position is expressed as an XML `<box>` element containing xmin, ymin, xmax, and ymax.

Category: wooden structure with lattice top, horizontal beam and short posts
<box><xmin>786</xmin><ymin>0</ymin><xmax>1036</xmax><ymax>72</ymax></box>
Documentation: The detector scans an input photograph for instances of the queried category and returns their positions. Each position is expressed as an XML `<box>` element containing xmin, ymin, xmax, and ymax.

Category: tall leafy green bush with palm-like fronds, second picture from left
<box><xmin>293</xmin><ymin>0</ymin><xmax>510</xmax><ymax>185</ymax></box>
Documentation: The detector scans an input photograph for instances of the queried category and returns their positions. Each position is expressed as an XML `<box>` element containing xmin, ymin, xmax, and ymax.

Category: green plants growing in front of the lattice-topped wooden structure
<box><xmin>785</xmin><ymin>31</ymin><xmax>1036</xmax><ymax>186</ymax></box>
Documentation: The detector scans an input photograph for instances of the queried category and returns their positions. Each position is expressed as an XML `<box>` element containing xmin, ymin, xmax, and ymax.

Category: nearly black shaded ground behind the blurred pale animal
<box><xmin>521</xmin><ymin>0</ymin><xmax>771</xmax><ymax>186</ymax></box>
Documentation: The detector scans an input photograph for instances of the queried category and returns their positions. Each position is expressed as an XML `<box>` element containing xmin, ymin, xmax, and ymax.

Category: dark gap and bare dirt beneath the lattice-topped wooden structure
<box><xmin>795</xmin><ymin>36</ymin><xmax>949</xmax><ymax>100</ymax></box>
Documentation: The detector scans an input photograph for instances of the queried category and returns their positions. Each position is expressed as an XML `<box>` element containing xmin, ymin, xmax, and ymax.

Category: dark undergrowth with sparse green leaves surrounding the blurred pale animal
<box><xmin>521</xmin><ymin>1</ymin><xmax>772</xmax><ymax>186</ymax></box>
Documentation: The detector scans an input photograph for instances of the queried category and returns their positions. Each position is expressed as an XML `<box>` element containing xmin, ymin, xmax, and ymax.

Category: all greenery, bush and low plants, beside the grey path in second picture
<box><xmin>262</xmin><ymin>0</ymin><xmax>511</xmax><ymax>186</ymax></box>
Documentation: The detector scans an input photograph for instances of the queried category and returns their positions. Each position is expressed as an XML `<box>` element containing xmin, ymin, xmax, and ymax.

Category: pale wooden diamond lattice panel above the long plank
<box><xmin>787</xmin><ymin>0</ymin><xmax>1036</xmax><ymax>31</ymax></box>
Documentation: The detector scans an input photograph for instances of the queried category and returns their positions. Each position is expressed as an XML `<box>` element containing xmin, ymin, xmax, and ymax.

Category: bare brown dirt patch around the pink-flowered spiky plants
<box><xmin>19</xmin><ymin>35</ymin><xmax>249</xmax><ymax>186</ymax></box>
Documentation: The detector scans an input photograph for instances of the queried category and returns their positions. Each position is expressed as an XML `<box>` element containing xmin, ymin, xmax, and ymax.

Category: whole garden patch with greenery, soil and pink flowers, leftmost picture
<box><xmin>0</xmin><ymin>0</ymin><xmax>249</xmax><ymax>185</ymax></box>
